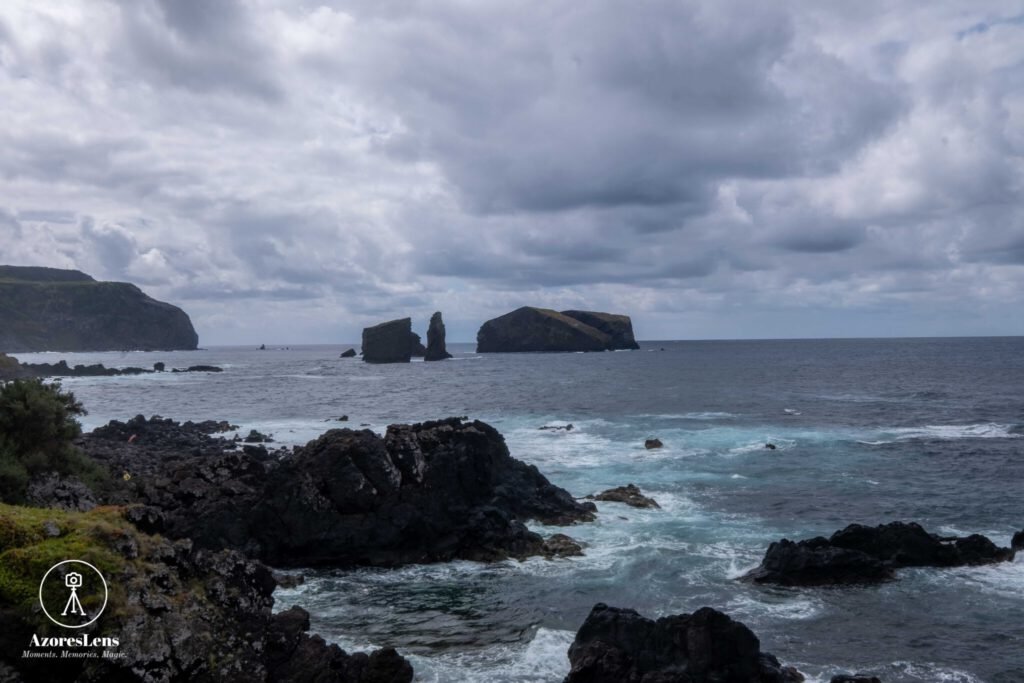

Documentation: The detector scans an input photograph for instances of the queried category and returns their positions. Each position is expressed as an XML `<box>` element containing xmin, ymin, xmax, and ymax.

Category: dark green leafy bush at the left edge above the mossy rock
<box><xmin>0</xmin><ymin>379</ymin><xmax>109</xmax><ymax>503</ymax></box>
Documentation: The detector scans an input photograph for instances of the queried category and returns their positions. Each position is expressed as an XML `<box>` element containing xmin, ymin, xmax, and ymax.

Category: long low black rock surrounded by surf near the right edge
<box><xmin>744</xmin><ymin>521</ymin><xmax>1014</xmax><ymax>586</ymax></box>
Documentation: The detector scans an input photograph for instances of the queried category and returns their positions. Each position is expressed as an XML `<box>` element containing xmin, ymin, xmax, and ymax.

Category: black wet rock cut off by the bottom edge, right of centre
<box><xmin>564</xmin><ymin>603</ymin><xmax>804</xmax><ymax>683</ymax></box>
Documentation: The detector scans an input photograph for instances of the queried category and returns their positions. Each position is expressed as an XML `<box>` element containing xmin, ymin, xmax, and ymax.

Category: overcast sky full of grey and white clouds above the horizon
<box><xmin>0</xmin><ymin>0</ymin><xmax>1024</xmax><ymax>344</ymax></box>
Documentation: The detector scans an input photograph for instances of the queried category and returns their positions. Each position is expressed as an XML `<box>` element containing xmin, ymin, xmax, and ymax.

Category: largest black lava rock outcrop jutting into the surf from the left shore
<box><xmin>82</xmin><ymin>418</ymin><xmax>594</xmax><ymax>566</ymax></box>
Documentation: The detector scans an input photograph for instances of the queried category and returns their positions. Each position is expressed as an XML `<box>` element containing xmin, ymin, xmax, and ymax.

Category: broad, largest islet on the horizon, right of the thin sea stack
<box><xmin>476</xmin><ymin>306</ymin><xmax>637</xmax><ymax>353</ymax></box>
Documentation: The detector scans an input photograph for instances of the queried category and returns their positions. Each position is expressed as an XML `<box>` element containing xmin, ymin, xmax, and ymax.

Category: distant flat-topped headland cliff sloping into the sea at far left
<box><xmin>0</xmin><ymin>265</ymin><xmax>199</xmax><ymax>352</ymax></box>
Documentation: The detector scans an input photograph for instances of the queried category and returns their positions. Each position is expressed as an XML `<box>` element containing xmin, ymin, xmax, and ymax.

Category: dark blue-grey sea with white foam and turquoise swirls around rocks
<box><xmin>9</xmin><ymin>338</ymin><xmax>1024</xmax><ymax>683</ymax></box>
